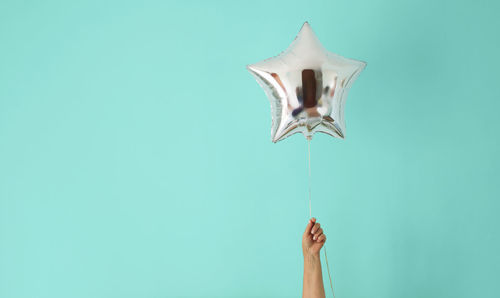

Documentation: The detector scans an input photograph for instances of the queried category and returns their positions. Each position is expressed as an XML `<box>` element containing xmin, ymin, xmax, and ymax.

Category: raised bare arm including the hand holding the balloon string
<box><xmin>302</xmin><ymin>217</ymin><xmax>326</xmax><ymax>298</ymax></box>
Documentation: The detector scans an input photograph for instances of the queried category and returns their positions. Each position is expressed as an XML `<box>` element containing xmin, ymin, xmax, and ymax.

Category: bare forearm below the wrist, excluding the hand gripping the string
<box><xmin>302</xmin><ymin>253</ymin><xmax>325</xmax><ymax>298</ymax></box>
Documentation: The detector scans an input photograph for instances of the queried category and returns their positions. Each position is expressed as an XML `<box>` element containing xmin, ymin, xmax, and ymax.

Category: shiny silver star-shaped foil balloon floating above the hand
<box><xmin>247</xmin><ymin>22</ymin><xmax>366</xmax><ymax>143</ymax></box>
